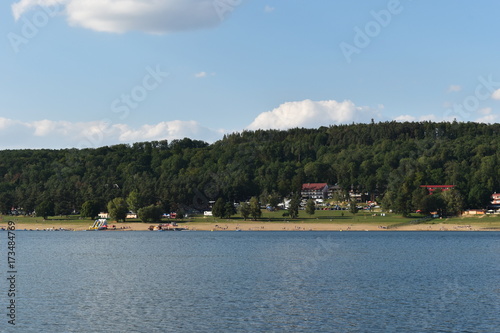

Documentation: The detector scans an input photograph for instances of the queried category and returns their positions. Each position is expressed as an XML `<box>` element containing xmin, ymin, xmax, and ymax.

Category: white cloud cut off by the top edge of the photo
<box><xmin>12</xmin><ymin>0</ymin><xmax>241</xmax><ymax>34</ymax></box>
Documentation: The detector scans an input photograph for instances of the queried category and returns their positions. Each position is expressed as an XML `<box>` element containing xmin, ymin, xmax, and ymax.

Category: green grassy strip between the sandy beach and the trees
<box><xmin>0</xmin><ymin>210</ymin><xmax>500</xmax><ymax>230</ymax></box>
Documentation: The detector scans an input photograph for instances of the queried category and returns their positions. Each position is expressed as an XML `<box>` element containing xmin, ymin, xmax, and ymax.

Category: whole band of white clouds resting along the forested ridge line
<box><xmin>0</xmin><ymin>100</ymin><xmax>470</xmax><ymax>149</ymax></box>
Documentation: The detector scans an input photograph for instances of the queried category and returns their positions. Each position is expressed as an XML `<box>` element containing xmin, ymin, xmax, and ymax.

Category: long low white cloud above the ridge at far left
<box><xmin>0</xmin><ymin>118</ymin><xmax>225</xmax><ymax>149</ymax></box>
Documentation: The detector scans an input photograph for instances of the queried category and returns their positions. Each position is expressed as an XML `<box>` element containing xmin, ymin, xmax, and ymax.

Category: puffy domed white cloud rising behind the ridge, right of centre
<box><xmin>248</xmin><ymin>99</ymin><xmax>380</xmax><ymax>130</ymax></box>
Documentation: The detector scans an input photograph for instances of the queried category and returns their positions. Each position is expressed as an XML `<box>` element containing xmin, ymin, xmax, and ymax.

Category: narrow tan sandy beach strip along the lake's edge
<box><xmin>4</xmin><ymin>221</ymin><xmax>500</xmax><ymax>231</ymax></box>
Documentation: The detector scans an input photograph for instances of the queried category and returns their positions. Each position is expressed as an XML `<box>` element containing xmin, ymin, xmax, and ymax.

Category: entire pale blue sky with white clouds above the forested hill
<box><xmin>0</xmin><ymin>0</ymin><xmax>500</xmax><ymax>149</ymax></box>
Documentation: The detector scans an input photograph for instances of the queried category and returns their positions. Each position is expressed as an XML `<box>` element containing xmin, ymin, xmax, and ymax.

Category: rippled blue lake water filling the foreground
<box><xmin>0</xmin><ymin>231</ymin><xmax>500</xmax><ymax>333</ymax></box>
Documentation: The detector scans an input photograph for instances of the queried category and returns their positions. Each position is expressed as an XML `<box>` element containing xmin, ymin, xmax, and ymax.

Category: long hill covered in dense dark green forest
<box><xmin>0</xmin><ymin>122</ymin><xmax>500</xmax><ymax>214</ymax></box>
